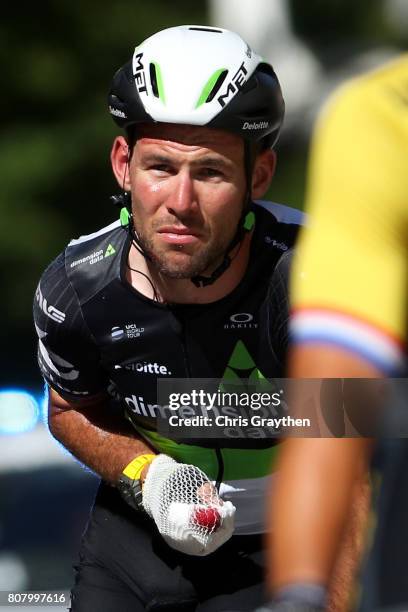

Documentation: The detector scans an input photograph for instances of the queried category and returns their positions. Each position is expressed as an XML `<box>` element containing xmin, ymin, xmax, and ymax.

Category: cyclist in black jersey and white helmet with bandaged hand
<box><xmin>34</xmin><ymin>26</ymin><xmax>300</xmax><ymax>612</ymax></box>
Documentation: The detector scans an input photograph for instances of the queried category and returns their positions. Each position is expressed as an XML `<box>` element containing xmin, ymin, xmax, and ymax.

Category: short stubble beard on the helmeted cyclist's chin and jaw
<box><xmin>135</xmin><ymin>224</ymin><xmax>236</xmax><ymax>279</ymax></box>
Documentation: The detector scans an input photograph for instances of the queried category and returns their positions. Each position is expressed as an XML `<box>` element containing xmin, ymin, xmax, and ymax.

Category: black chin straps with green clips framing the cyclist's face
<box><xmin>110</xmin><ymin>141</ymin><xmax>255</xmax><ymax>287</ymax></box>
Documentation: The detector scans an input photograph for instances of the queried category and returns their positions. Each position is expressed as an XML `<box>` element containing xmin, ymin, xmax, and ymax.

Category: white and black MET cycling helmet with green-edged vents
<box><xmin>109</xmin><ymin>25</ymin><xmax>284</xmax><ymax>147</ymax></box>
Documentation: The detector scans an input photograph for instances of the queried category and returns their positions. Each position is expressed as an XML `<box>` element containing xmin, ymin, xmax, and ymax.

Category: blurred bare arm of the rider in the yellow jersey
<box><xmin>269</xmin><ymin>345</ymin><xmax>379</xmax><ymax>611</ymax></box>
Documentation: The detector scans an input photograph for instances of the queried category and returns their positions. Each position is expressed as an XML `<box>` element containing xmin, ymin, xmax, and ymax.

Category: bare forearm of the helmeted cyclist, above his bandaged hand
<box><xmin>48</xmin><ymin>389</ymin><xmax>154</xmax><ymax>484</ymax></box>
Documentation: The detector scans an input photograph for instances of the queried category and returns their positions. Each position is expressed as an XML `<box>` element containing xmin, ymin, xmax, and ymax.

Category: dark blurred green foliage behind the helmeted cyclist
<box><xmin>0</xmin><ymin>0</ymin><xmax>404</xmax><ymax>386</ymax></box>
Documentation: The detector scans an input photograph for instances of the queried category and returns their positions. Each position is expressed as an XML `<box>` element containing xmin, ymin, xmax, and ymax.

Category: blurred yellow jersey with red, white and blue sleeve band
<box><xmin>291</xmin><ymin>54</ymin><xmax>408</xmax><ymax>374</ymax></box>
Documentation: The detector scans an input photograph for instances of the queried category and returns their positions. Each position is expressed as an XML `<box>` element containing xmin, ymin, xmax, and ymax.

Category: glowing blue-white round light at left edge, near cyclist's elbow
<box><xmin>0</xmin><ymin>389</ymin><xmax>40</xmax><ymax>435</ymax></box>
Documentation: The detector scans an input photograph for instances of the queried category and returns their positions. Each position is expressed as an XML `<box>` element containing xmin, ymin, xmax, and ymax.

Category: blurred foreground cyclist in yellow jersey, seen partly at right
<box><xmin>255</xmin><ymin>55</ymin><xmax>408</xmax><ymax>612</ymax></box>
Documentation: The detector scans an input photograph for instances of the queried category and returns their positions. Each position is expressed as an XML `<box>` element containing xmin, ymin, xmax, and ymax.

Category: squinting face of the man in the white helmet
<box><xmin>129</xmin><ymin>124</ymin><xmax>246</xmax><ymax>278</ymax></box>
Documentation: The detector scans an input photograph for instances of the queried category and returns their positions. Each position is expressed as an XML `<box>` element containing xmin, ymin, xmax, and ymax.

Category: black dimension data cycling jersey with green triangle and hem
<box><xmin>34</xmin><ymin>202</ymin><xmax>301</xmax><ymax>533</ymax></box>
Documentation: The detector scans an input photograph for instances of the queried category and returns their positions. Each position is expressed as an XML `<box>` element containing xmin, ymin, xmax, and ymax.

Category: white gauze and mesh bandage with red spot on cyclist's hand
<box><xmin>143</xmin><ymin>455</ymin><xmax>235</xmax><ymax>556</ymax></box>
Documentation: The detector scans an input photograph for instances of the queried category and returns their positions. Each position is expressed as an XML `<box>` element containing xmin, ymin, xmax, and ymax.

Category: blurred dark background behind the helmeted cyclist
<box><xmin>0</xmin><ymin>0</ymin><xmax>408</xmax><ymax>609</ymax></box>
